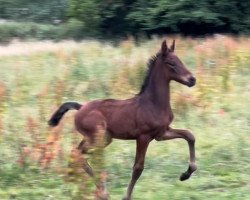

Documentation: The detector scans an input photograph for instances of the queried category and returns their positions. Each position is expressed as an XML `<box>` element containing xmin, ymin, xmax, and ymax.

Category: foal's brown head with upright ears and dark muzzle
<box><xmin>160</xmin><ymin>40</ymin><xmax>196</xmax><ymax>87</ymax></box>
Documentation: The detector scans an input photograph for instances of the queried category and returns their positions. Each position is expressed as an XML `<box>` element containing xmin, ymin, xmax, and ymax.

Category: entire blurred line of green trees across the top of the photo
<box><xmin>0</xmin><ymin>0</ymin><xmax>250</xmax><ymax>37</ymax></box>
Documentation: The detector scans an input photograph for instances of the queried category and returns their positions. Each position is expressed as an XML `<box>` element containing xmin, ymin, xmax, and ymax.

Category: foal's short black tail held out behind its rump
<box><xmin>48</xmin><ymin>102</ymin><xmax>82</xmax><ymax>126</ymax></box>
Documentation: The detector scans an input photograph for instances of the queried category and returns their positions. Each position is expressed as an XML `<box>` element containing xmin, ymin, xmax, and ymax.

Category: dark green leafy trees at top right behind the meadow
<box><xmin>69</xmin><ymin>0</ymin><xmax>250</xmax><ymax>36</ymax></box>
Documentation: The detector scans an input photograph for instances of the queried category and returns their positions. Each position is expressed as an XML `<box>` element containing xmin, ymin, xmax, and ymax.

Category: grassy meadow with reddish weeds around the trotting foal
<box><xmin>0</xmin><ymin>35</ymin><xmax>250</xmax><ymax>200</ymax></box>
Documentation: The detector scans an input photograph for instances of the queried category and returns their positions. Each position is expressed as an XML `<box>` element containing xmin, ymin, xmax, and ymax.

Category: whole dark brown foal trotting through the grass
<box><xmin>49</xmin><ymin>40</ymin><xmax>197</xmax><ymax>200</ymax></box>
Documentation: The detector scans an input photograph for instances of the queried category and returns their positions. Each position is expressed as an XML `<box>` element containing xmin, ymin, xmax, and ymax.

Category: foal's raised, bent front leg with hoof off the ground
<box><xmin>155</xmin><ymin>128</ymin><xmax>197</xmax><ymax>181</ymax></box>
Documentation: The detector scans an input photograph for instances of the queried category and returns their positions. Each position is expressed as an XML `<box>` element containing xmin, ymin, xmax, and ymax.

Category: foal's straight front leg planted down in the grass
<box><xmin>123</xmin><ymin>136</ymin><xmax>152</xmax><ymax>200</ymax></box>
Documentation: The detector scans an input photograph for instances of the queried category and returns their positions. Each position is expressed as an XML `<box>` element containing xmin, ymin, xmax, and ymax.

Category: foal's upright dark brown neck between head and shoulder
<box><xmin>142</xmin><ymin>66</ymin><xmax>171</xmax><ymax>112</ymax></box>
